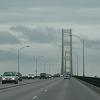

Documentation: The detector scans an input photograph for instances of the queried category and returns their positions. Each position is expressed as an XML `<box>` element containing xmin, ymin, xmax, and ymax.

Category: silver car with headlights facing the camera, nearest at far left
<box><xmin>2</xmin><ymin>72</ymin><xmax>18</xmax><ymax>84</ymax></box>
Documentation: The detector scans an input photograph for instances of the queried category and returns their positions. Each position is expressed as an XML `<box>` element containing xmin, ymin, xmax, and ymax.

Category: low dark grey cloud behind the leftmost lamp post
<box><xmin>0</xmin><ymin>49</ymin><xmax>33</xmax><ymax>65</ymax></box>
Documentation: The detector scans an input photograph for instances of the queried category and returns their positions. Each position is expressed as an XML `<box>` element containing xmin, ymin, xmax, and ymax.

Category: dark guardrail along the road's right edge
<box><xmin>73</xmin><ymin>76</ymin><xmax>100</xmax><ymax>87</ymax></box>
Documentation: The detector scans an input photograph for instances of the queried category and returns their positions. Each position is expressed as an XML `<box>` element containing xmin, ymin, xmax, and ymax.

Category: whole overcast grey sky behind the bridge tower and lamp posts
<box><xmin>0</xmin><ymin>0</ymin><xmax>100</xmax><ymax>76</ymax></box>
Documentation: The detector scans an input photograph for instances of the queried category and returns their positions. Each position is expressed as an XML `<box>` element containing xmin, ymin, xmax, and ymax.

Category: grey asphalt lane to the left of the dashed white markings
<box><xmin>0</xmin><ymin>78</ymin><xmax>61</xmax><ymax>100</ymax></box>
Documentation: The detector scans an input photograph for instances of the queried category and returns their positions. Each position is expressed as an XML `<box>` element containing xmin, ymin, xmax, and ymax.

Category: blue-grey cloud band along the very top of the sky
<box><xmin>0</xmin><ymin>0</ymin><xmax>100</xmax><ymax>9</ymax></box>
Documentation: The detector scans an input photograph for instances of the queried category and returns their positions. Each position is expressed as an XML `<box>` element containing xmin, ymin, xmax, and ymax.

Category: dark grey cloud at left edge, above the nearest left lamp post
<box><xmin>0</xmin><ymin>31</ymin><xmax>20</xmax><ymax>44</ymax></box>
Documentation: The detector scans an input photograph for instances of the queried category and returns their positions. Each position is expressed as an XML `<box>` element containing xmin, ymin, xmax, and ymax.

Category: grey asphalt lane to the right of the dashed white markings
<box><xmin>36</xmin><ymin>78</ymin><xmax>100</xmax><ymax>100</ymax></box>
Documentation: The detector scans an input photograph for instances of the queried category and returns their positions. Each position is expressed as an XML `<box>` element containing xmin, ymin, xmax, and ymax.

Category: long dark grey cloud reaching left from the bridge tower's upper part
<box><xmin>11</xmin><ymin>26</ymin><xmax>60</xmax><ymax>43</ymax></box>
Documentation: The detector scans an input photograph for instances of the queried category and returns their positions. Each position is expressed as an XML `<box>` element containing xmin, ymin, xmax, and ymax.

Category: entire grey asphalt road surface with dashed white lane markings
<box><xmin>0</xmin><ymin>78</ymin><xmax>100</xmax><ymax>100</ymax></box>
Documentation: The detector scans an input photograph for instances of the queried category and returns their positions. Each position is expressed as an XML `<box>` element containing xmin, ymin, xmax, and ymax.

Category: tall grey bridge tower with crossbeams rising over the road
<box><xmin>61</xmin><ymin>29</ymin><xmax>73</xmax><ymax>75</ymax></box>
